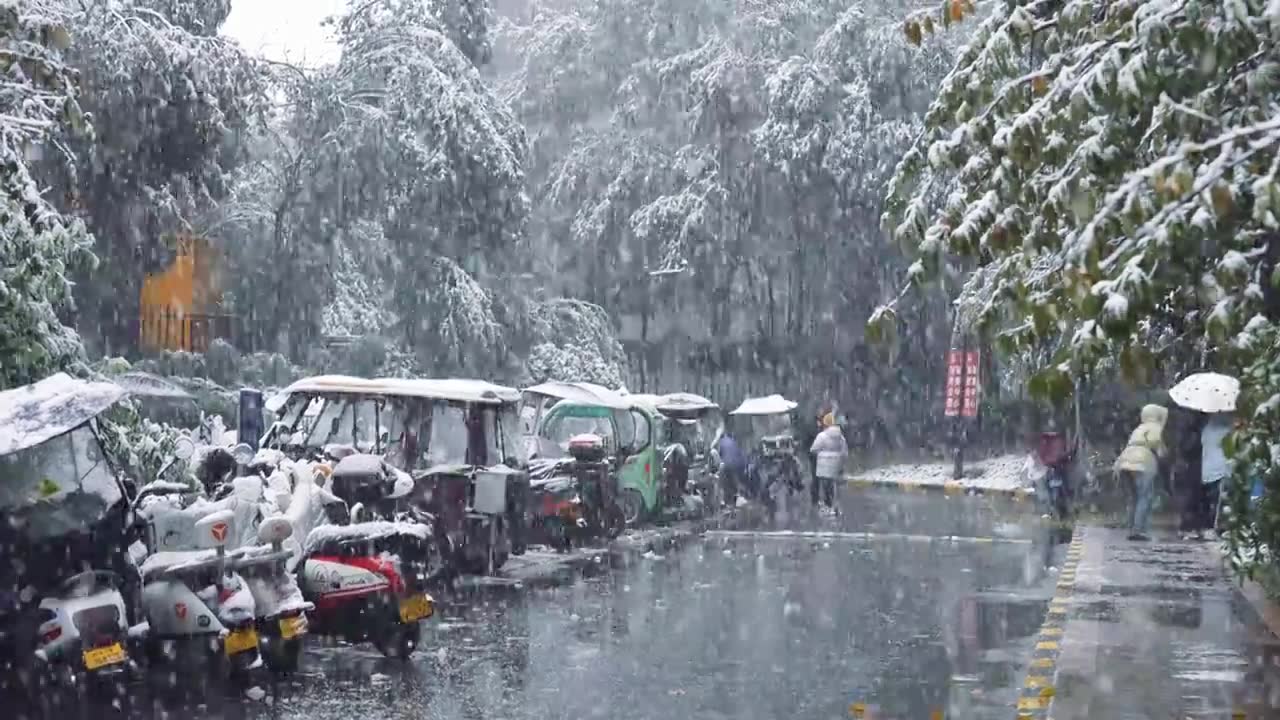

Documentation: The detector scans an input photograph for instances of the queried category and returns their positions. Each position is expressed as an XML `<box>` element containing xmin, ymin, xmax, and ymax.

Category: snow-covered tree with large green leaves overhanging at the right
<box><xmin>878</xmin><ymin>0</ymin><xmax>1280</xmax><ymax>566</ymax></box>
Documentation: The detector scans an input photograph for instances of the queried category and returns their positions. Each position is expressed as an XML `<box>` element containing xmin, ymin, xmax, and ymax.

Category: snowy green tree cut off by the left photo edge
<box><xmin>0</xmin><ymin>0</ymin><xmax>92</xmax><ymax>388</ymax></box>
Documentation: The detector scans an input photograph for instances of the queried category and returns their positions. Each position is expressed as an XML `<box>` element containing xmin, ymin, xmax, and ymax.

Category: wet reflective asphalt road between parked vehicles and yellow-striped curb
<box><xmin>183</xmin><ymin>489</ymin><xmax>1066</xmax><ymax>720</ymax></box>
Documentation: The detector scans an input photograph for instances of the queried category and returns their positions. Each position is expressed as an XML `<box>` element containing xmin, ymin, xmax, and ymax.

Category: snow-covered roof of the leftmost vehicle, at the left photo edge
<box><xmin>0</xmin><ymin>373</ymin><xmax>128</xmax><ymax>455</ymax></box>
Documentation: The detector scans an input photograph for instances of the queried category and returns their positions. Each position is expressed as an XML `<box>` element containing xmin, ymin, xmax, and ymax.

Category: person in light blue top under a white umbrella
<box><xmin>1169</xmin><ymin>373</ymin><xmax>1240</xmax><ymax>539</ymax></box>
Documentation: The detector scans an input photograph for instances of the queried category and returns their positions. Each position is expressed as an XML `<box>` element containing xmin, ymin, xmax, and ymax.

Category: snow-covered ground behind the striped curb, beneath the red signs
<box><xmin>847</xmin><ymin>455</ymin><xmax>1036</xmax><ymax>501</ymax></box>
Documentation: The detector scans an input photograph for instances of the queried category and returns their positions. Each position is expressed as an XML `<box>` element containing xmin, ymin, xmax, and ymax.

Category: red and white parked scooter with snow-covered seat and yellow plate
<box><xmin>291</xmin><ymin>454</ymin><xmax>435</xmax><ymax>657</ymax></box>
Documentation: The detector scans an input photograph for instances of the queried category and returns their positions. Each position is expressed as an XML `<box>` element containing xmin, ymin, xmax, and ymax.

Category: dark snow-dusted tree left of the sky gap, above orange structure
<box><xmin>45</xmin><ymin>0</ymin><xmax>264</xmax><ymax>351</ymax></box>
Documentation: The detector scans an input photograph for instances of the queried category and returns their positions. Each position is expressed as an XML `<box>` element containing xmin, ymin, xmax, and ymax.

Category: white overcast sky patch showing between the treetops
<box><xmin>223</xmin><ymin>0</ymin><xmax>343</xmax><ymax>65</ymax></box>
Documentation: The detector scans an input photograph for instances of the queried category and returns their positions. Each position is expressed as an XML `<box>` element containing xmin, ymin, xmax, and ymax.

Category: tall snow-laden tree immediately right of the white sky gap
<box><xmin>311</xmin><ymin>0</ymin><xmax>527</xmax><ymax>364</ymax></box>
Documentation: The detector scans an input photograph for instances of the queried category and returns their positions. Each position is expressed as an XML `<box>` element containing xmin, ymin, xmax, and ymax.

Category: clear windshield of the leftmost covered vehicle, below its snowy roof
<box><xmin>0</xmin><ymin>424</ymin><xmax>123</xmax><ymax>539</ymax></box>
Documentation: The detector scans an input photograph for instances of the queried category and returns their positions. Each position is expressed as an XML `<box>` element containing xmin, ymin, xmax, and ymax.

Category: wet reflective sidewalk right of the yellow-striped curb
<box><xmin>1019</xmin><ymin>527</ymin><xmax>1280</xmax><ymax>720</ymax></box>
